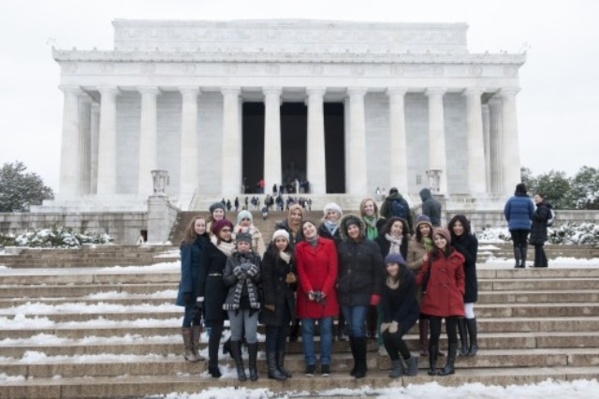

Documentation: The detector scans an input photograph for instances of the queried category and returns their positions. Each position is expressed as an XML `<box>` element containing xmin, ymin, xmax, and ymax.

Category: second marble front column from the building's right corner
<box><xmin>464</xmin><ymin>88</ymin><xmax>487</xmax><ymax>194</ymax></box>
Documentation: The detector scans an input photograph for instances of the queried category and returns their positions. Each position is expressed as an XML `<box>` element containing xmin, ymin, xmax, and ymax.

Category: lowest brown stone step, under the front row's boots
<box><xmin>2</xmin><ymin>367</ymin><xmax>597</xmax><ymax>399</ymax></box>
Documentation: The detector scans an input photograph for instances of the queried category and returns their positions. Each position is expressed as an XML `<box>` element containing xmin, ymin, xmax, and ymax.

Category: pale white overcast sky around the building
<box><xmin>0</xmin><ymin>0</ymin><xmax>599</xmax><ymax>190</ymax></box>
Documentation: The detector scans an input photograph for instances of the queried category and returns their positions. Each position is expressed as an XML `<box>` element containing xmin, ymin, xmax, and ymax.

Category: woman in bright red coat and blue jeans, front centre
<box><xmin>295</xmin><ymin>221</ymin><xmax>339</xmax><ymax>377</ymax></box>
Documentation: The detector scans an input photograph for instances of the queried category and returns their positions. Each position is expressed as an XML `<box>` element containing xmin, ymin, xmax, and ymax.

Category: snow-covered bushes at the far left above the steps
<box><xmin>0</xmin><ymin>226</ymin><xmax>113</xmax><ymax>248</ymax></box>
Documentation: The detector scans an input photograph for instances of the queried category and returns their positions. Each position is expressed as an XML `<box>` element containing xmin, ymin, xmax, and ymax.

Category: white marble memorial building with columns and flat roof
<box><xmin>53</xmin><ymin>19</ymin><xmax>526</xmax><ymax>210</ymax></box>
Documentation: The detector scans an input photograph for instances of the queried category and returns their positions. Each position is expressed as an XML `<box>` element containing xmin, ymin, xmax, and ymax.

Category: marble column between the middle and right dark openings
<box><xmin>306</xmin><ymin>87</ymin><xmax>327</xmax><ymax>194</ymax></box>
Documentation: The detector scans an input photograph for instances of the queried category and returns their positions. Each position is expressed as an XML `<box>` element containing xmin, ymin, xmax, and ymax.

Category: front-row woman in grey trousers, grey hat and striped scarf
<box><xmin>223</xmin><ymin>233</ymin><xmax>262</xmax><ymax>381</ymax></box>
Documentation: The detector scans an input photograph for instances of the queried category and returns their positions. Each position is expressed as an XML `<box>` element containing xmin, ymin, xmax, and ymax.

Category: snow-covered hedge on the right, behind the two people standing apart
<box><xmin>476</xmin><ymin>223</ymin><xmax>599</xmax><ymax>245</ymax></box>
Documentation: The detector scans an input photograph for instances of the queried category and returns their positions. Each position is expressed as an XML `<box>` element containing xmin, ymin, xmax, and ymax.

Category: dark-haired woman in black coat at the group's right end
<box><xmin>448</xmin><ymin>215</ymin><xmax>478</xmax><ymax>356</ymax></box>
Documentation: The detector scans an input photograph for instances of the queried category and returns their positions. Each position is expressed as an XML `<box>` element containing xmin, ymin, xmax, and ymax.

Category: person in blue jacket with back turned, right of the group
<box><xmin>503</xmin><ymin>183</ymin><xmax>535</xmax><ymax>269</ymax></box>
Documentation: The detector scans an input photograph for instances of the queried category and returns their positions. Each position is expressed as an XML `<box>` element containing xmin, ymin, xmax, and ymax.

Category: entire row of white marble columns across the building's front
<box><xmin>60</xmin><ymin>86</ymin><xmax>520</xmax><ymax>196</ymax></box>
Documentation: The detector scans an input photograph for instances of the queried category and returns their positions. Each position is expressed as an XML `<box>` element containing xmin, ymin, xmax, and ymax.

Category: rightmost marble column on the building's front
<box><xmin>500</xmin><ymin>88</ymin><xmax>522</xmax><ymax>194</ymax></box>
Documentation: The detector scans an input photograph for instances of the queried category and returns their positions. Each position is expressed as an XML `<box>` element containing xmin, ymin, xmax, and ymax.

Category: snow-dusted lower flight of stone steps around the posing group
<box><xmin>0</xmin><ymin>255</ymin><xmax>599</xmax><ymax>398</ymax></box>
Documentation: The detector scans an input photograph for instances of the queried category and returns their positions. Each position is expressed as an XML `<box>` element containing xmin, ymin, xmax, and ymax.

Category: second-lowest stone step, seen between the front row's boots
<box><xmin>0</xmin><ymin>349</ymin><xmax>599</xmax><ymax>379</ymax></box>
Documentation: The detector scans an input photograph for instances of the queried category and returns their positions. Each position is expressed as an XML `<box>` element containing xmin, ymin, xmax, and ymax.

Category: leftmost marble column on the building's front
<box><xmin>59</xmin><ymin>86</ymin><xmax>82</xmax><ymax>198</ymax></box>
